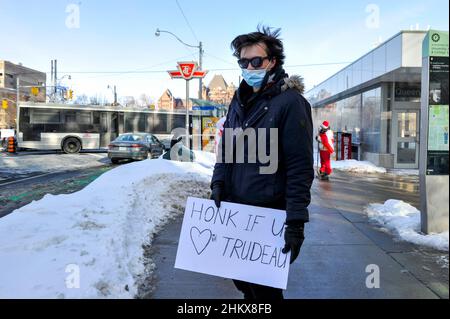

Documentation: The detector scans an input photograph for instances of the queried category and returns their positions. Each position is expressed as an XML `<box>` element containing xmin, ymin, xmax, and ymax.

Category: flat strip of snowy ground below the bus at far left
<box><xmin>0</xmin><ymin>153</ymin><xmax>110</xmax><ymax>174</ymax></box>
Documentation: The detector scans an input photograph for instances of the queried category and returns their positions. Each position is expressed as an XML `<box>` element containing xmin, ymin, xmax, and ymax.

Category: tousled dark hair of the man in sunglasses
<box><xmin>231</xmin><ymin>25</ymin><xmax>286</xmax><ymax>69</ymax></box>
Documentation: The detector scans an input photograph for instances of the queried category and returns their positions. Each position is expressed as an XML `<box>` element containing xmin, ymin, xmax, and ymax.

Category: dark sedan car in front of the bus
<box><xmin>108</xmin><ymin>133</ymin><xmax>165</xmax><ymax>164</ymax></box>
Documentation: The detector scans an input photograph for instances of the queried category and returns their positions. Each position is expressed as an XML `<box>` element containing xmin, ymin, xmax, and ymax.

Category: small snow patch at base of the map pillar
<box><xmin>367</xmin><ymin>199</ymin><xmax>449</xmax><ymax>251</ymax></box>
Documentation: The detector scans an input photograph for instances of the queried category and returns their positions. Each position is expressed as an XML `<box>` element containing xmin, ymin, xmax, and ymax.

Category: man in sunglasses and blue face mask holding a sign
<box><xmin>211</xmin><ymin>27</ymin><xmax>314</xmax><ymax>299</ymax></box>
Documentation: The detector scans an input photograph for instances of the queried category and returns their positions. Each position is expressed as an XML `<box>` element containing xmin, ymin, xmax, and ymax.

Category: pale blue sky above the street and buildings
<box><xmin>0</xmin><ymin>0</ymin><xmax>449</xmax><ymax>99</ymax></box>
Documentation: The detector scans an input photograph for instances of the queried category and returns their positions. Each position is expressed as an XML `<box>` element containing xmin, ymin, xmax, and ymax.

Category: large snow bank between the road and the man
<box><xmin>0</xmin><ymin>153</ymin><xmax>214</xmax><ymax>298</ymax></box>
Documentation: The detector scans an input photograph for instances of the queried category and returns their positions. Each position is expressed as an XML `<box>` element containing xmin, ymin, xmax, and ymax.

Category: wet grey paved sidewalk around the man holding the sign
<box><xmin>146</xmin><ymin>173</ymin><xmax>449</xmax><ymax>299</ymax></box>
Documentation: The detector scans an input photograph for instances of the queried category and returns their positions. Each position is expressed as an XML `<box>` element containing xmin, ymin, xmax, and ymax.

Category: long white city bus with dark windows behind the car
<box><xmin>18</xmin><ymin>102</ymin><xmax>194</xmax><ymax>153</ymax></box>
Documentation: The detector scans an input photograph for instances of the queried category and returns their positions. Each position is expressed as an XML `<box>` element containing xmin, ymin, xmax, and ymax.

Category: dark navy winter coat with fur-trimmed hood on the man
<box><xmin>211</xmin><ymin>69</ymin><xmax>314</xmax><ymax>223</ymax></box>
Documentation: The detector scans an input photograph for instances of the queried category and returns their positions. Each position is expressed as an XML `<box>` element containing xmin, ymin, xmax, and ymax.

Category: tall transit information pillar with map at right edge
<box><xmin>419</xmin><ymin>30</ymin><xmax>449</xmax><ymax>234</ymax></box>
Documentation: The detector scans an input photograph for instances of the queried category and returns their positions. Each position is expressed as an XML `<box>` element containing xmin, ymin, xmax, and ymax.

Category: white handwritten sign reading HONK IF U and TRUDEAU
<box><xmin>175</xmin><ymin>197</ymin><xmax>290</xmax><ymax>289</ymax></box>
